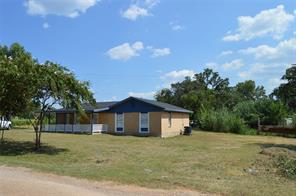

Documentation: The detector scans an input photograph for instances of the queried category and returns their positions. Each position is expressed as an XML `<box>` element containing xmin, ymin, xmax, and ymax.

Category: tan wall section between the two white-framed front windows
<box><xmin>124</xmin><ymin>112</ymin><xmax>139</xmax><ymax>135</ymax></box>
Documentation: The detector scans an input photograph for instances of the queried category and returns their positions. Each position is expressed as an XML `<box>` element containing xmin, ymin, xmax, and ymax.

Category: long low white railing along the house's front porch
<box><xmin>42</xmin><ymin>124</ymin><xmax>108</xmax><ymax>134</ymax></box>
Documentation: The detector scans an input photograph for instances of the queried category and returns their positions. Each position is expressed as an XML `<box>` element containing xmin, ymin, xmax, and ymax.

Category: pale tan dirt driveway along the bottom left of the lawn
<box><xmin>0</xmin><ymin>166</ymin><xmax>210</xmax><ymax>196</ymax></box>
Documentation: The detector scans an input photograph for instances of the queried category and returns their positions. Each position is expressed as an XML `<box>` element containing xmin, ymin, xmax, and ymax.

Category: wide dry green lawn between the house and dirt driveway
<box><xmin>0</xmin><ymin>129</ymin><xmax>296</xmax><ymax>195</ymax></box>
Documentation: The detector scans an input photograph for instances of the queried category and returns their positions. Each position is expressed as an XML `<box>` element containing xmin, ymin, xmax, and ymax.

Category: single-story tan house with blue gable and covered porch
<box><xmin>43</xmin><ymin>97</ymin><xmax>192</xmax><ymax>137</ymax></box>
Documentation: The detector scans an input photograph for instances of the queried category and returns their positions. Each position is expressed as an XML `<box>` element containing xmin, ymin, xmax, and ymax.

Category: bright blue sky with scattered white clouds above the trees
<box><xmin>0</xmin><ymin>0</ymin><xmax>296</xmax><ymax>101</ymax></box>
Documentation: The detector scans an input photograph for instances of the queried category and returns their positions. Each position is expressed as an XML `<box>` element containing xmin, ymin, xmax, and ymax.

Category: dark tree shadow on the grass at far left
<box><xmin>0</xmin><ymin>140</ymin><xmax>68</xmax><ymax>156</ymax></box>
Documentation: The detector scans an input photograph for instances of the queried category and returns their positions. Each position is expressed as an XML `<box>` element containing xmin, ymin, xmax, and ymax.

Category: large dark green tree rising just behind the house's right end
<box><xmin>155</xmin><ymin>69</ymin><xmax>230</xmax><ymax>119</ymax></box>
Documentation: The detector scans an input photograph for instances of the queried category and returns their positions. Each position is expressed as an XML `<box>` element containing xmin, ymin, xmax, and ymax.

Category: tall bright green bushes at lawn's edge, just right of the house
<box><xmin>199</xmin><ymin>109</ymin><xmax>254</xmax><ymax>134</ymax></box>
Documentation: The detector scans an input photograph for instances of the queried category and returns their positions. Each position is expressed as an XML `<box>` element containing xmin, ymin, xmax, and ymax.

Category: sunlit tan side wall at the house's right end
<box><xmin>161</xmin><ymin>112</ymin><xmax>189</xmax><ymax>137</ymax></box>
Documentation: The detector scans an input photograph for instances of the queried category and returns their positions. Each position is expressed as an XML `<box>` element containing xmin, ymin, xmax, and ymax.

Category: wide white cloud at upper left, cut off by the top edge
<box><xmin>24</xmin><ymin>0</ymin><xmax>100</xmax><ymax>18</ymax></box>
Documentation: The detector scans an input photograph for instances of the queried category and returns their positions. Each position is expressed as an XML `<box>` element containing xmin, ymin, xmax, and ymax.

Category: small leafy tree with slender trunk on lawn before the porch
<box><xmin>32</xmin><ymin>61</ymin><xmax>95</xmax><ymax>149</ymax></box>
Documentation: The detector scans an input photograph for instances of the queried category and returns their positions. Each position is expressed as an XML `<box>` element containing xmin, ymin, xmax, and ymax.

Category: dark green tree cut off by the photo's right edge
<box><xmin>272</xmin><ymin>64</ymin><xmax>296</xmax><ymax>112</ymax></box>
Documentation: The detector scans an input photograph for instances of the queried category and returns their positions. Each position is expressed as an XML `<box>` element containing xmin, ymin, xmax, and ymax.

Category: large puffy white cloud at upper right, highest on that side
<box><xmin>223</xmin><ymin>5</ymin><xmax>295</xmax><ymax>41</ymax></box>
